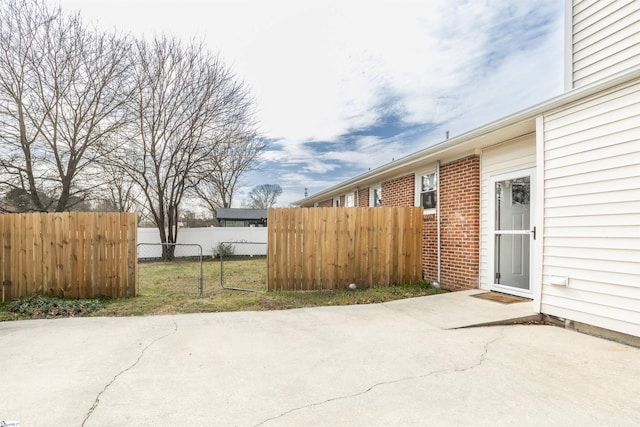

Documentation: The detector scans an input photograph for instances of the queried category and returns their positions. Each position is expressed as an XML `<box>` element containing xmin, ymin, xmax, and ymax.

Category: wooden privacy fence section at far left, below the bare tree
<box><xmin>0</xmin><ymin>212</ymin><xmax>138</xmax><ymax>299</ymax></box>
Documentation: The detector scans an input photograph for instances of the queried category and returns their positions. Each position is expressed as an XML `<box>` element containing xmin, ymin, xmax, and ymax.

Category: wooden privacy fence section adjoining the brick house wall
<box><xmin>267</xmin><ymin>207</ymin><xmax>423</xmax><ymax>290</ymax></box>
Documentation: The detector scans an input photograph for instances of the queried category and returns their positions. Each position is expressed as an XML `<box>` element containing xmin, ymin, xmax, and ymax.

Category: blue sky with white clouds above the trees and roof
<box><xmin>52</xmin><ymin>0</ymin><xmax>564</xmax><ymax>207</ymax></box>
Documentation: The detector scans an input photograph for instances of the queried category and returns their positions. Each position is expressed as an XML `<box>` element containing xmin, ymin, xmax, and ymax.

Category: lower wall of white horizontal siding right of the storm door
<box><xmin>541</xmin><ymin>82</ymin><xmax>640</xmax><ymax>335</ymax></box>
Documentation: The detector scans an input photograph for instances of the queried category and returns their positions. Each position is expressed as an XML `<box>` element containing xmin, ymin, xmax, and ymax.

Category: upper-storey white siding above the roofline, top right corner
<box><xmin>569</xmin><ymin>0</ymin><xmax>640</xmax><ymax>87</ymax></box>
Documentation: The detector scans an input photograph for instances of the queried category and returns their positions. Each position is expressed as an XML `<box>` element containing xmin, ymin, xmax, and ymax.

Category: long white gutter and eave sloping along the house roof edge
<box><xmin>293</xmin><ymin>65</ymin><xmax>640</xmax><ymax>205</ymax></box>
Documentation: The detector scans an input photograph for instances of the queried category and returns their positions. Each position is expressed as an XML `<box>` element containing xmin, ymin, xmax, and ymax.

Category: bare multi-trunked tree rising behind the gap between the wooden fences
<box><xmin>121</xmin><ymin>37</ymin><xmax>251</xmax><ymax>259</ymax></box>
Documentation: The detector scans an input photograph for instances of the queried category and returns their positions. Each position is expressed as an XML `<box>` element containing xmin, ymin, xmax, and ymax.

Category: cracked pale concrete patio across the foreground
<box><xmin>0</xmin><ymin>291</ymin><xmax>640</xmax><ymax>427</ymax></box>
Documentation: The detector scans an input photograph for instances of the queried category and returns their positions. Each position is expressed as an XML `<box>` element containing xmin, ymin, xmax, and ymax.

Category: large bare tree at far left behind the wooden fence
<box><xmin>0</xmin><ymin>0</ymin><xmax>129</xmax><ymax>211</ymax></box>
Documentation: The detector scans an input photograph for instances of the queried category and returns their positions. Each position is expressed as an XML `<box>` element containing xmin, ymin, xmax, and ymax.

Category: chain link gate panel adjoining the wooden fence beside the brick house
<box><xmin>219</xmin><ymin>241</ymin><xmax>267</xmax><ymax>292</ymax></box>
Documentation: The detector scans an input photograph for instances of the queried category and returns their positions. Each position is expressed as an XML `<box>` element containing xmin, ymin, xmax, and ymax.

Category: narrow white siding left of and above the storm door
<box><xmin>480</xmin><ymin>135</ymin><xmax>536</xmax><ymax>289</ymax></box>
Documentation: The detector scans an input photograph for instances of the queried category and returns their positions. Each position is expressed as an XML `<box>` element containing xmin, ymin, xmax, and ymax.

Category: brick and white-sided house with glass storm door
<box><xmin>296</xmin><ymin>0</ymin><xmax>640</xmax><ymax>342</ymax></box>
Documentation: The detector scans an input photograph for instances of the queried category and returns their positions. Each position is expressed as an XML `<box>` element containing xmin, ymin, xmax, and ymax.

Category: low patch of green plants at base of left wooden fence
<box><xmin>8</xmin><ymin>295</ymin><xmax>102</xmax><ymax>318</ymax></box>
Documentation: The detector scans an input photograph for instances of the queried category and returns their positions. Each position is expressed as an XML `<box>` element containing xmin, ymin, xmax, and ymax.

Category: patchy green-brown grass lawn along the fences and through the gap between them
<box><xmin>0</xmin><ymin>258</ymin><xmax>444</xmax><ymax>321</ymax></box>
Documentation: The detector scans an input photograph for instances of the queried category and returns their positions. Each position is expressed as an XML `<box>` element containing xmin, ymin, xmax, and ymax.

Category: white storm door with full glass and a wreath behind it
<box><xmin>489</xmin><ymin>169</ymin><xmax>536</xmax><ymax>298</ymax></box>
